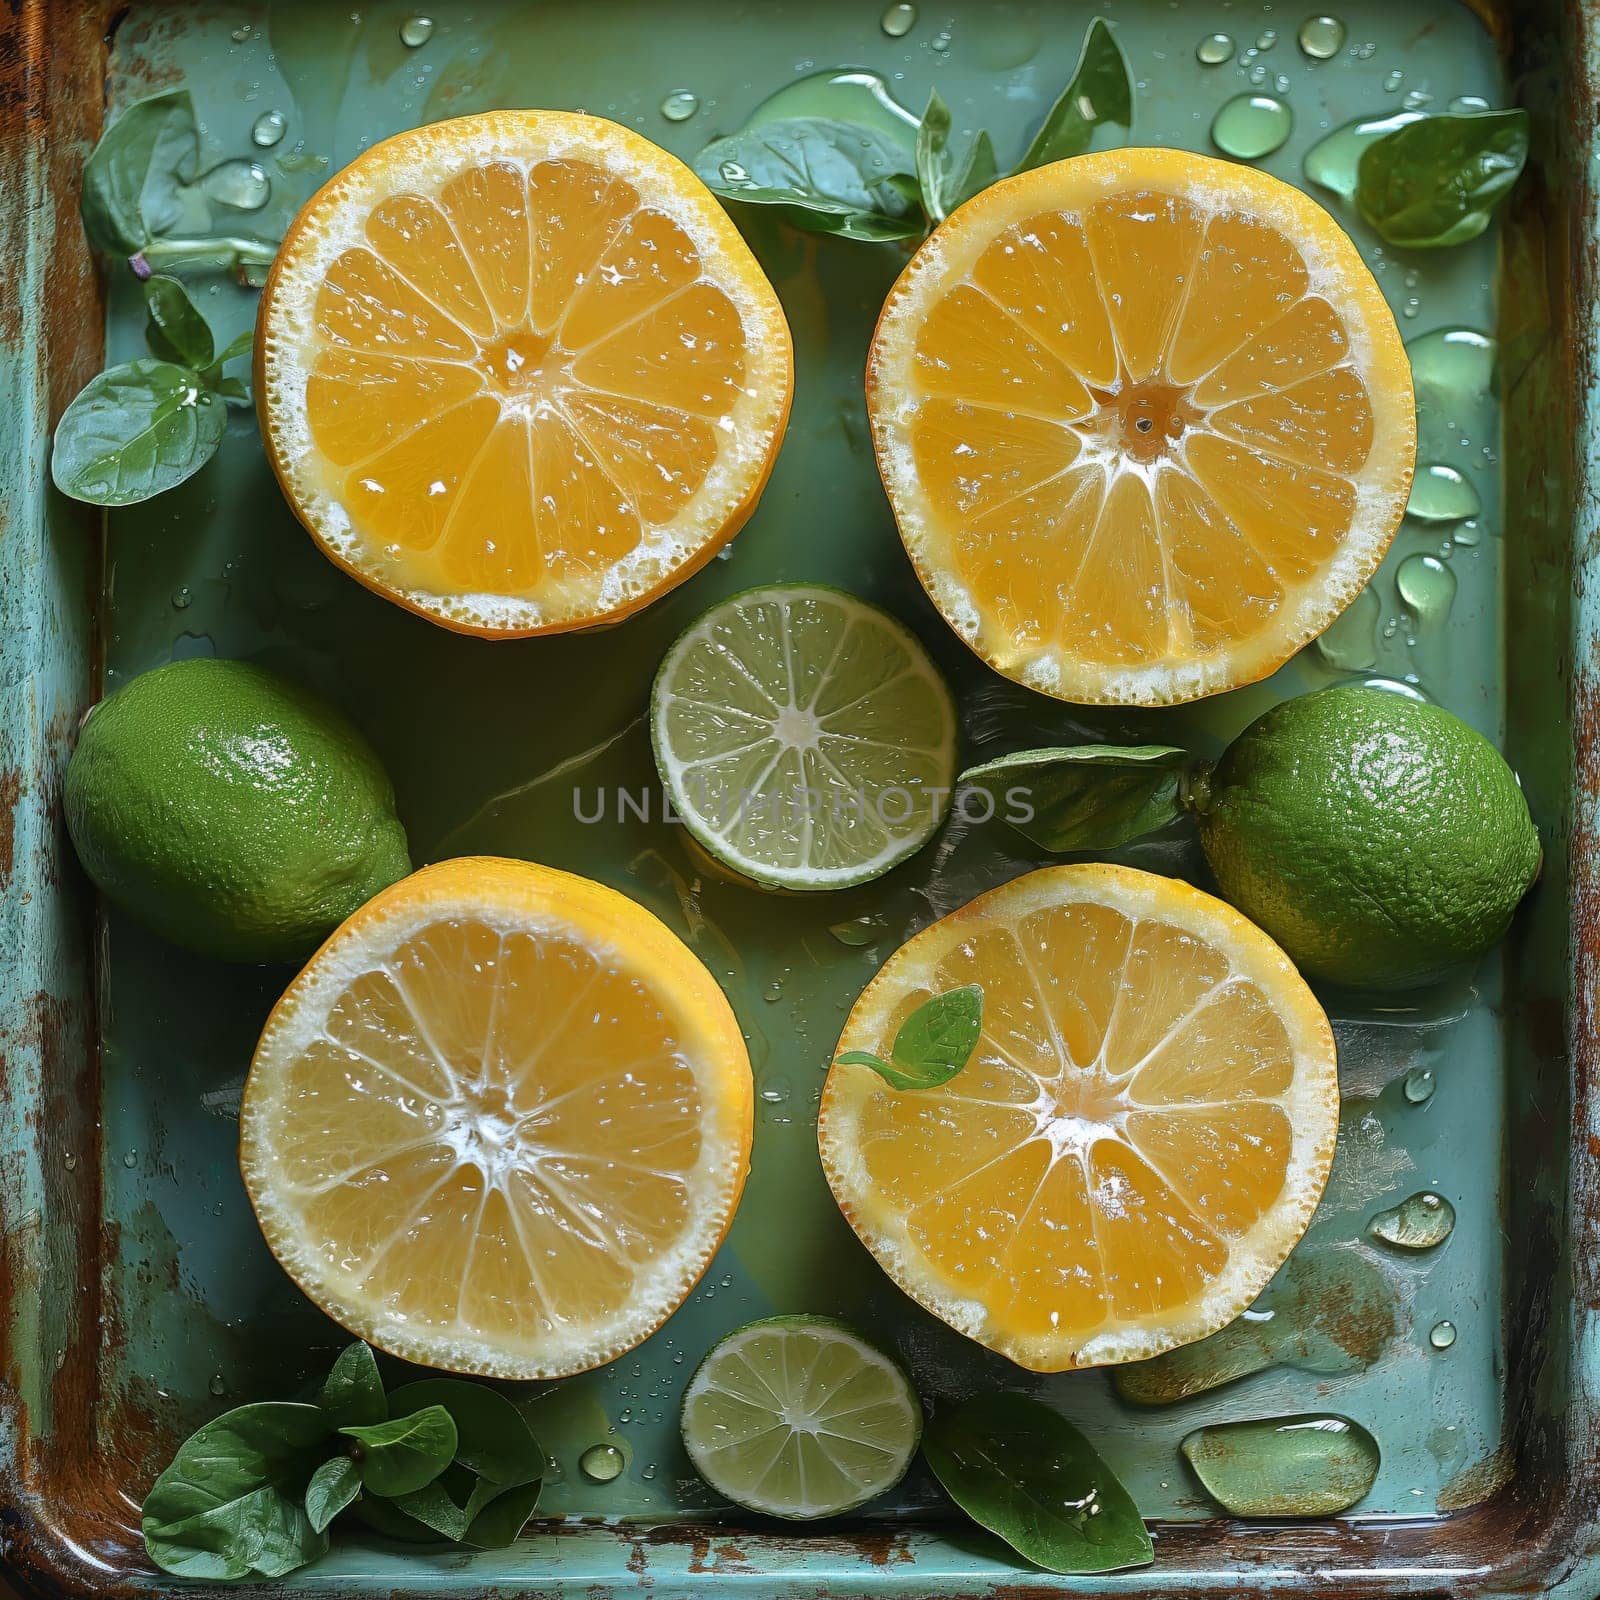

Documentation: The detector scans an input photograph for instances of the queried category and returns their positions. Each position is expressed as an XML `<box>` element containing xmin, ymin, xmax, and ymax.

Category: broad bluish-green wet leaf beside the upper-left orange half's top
<box><xmin>694</xmin><ymin>117</ymin><xmax>923</xmax><ymax>240</ymax></box>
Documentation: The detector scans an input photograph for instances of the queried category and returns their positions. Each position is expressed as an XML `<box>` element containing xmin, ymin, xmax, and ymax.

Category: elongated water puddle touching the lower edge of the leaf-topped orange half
<box><xmin>1112</xmin><ymin>1245</ymin><xmax>1395</xmax><ymax>1405</ymax></box>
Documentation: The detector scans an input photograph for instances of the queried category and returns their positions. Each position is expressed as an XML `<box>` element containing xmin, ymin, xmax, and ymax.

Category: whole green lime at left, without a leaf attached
<box><xmin>66</xmin><ymin>659</ymin><xmax>411</xmax><ymax>962</ymax></box>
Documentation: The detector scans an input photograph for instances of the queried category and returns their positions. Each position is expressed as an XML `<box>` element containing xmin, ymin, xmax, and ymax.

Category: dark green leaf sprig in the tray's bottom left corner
<box><xmin>142</xmin><ymin>1342</ymin><xmax>544</xmax><ymax>1582</ymax></box>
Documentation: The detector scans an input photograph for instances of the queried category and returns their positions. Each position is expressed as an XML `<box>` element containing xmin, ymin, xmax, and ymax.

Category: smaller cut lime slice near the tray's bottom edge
<box><xmin>683</xmin><ymin>1317</ymin><xmax>922</xmax><ymax>1520</ymax></box>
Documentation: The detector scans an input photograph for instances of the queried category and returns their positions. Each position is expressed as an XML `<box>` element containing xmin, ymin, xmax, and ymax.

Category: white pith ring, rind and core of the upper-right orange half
<box><xmin>867</xmin><ymin>150</ymin><xmax>1416</xmax><ymax>704</ymax></box>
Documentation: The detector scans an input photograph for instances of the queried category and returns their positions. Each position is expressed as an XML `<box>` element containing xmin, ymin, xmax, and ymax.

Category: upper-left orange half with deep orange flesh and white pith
<box><xmin>256</xmin><ymin>110</ymin><xmax>792</xmax><ymax>637</ymax></box>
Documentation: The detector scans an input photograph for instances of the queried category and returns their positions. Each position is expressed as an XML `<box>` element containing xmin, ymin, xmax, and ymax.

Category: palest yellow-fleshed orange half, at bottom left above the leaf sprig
<box><xmin>240</xmin><ymin>858</ymin><xmax>752</xmax><ymax>1378</ymax></box>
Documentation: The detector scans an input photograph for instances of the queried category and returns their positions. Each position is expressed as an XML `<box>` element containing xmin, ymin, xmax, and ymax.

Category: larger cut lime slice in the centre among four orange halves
<box><xmin>651</xmin><ymin>584</ymin><xmax>957</xmax><ymax>890</ymax></box>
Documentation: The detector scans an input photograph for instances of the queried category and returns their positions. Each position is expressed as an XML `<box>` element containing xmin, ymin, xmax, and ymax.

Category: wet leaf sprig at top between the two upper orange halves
<box><xmin>694</xmin><ymin>18</ymin><xmax>1133</xmax><ymax>242</ymax></box>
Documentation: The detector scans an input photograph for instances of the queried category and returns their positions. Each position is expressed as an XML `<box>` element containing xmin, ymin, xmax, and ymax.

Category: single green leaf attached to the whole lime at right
<box><xmin>960</xmin><ymin>744</ymin><xmax>1194</xmax><ymax>851</ymax></box>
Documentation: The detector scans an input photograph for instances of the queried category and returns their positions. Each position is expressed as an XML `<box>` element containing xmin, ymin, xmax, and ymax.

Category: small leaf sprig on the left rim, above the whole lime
<box><xmin>50</xmin><ymin>274</ymin><xmax>253</xmax><ymax>506</ymax></box>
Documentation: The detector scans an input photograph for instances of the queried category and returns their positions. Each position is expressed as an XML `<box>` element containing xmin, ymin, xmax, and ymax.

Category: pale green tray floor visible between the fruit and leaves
<box><xmin>96</xmin><ymin>0</ymin><xmax>1504</xmax><ymax>1536</ymax></box>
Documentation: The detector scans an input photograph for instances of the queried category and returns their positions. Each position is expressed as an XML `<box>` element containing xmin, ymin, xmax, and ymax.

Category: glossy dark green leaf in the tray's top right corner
<box><xmin>1355</xmin><ymin>110</ymin><xmax>1528</xmax><ymax>250</ymax></box>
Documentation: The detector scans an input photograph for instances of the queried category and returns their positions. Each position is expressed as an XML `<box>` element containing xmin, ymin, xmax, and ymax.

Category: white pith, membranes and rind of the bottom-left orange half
<box><xmin>240</xmin><ymin>862</ymin><xmax>752</xmax><ymax>1379</ymax></box>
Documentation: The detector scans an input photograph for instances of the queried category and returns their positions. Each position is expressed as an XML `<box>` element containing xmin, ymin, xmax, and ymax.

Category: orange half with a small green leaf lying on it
<box><xmin>819</xmin><ymin>866</ymin><xmax>1339</xmax><ymax>1371</ymax></box>
